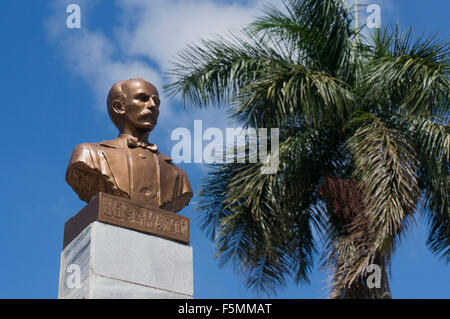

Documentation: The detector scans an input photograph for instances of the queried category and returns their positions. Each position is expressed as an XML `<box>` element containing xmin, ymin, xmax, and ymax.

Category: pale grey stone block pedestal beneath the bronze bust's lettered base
<box><xmin>58</xmin><ymin>221</ymin><xmax>194</xmax><ymax>299</ymax></box>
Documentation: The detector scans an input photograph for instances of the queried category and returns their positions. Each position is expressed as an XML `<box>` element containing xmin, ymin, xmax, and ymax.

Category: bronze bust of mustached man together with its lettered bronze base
<box><xmin>64</xmin><ymin>78</ymin><xmax>192</xmax><ymax>247</ymax></box>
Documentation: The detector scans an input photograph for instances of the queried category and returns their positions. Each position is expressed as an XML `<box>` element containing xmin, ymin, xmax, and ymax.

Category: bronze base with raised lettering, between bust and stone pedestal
<box><xmin>63</xmin><ymin>193</ymin><xmax>190</xmax><ymax>248</ymax></box>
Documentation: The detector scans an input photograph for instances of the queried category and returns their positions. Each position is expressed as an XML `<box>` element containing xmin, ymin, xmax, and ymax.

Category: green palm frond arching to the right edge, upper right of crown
<box><xmin>361</xmin><ymin>28</ymin><xmax>450</xmax><ymax>116</ymax></box>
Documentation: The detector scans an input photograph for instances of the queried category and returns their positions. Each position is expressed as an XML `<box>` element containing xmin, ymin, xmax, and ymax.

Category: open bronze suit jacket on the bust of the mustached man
<box><xmin>66</xmin><ymin>137</ymin><xmax>192</xmax><ymax>212</ymax></box>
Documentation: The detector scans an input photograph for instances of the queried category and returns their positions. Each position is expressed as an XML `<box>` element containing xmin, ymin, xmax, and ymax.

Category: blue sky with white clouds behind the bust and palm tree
<box><xmin>0</xmin><ymin>0</ymin><xmax>450</xmax><ymax>298</ymax></box>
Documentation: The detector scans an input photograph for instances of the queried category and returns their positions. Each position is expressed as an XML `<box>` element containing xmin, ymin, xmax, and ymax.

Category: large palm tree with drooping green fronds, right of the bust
<box><xmin>166</xmin><ymin>0</ymin><xmax>450</xmax><ymax>298</ymax></box>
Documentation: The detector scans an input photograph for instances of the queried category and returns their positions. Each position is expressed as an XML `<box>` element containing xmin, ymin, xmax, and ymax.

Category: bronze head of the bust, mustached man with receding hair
<box><xmin>107</xmin><ymin>78</ymin><xmax>160</xmax><ymax>132</ymax></box>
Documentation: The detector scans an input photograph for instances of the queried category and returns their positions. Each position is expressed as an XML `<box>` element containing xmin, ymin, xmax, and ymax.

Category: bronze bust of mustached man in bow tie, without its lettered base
<box><xmin>66</xmin><ymin>78</ymin><xmax>192</xmax><ymax>213</ymax></box>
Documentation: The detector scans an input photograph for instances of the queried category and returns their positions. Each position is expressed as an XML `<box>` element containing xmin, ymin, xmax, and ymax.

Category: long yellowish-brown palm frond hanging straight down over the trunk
<box><xmin>343</xmin><ymin>116</ymin><xmax>420</xmax><ymax>284</ymax></box>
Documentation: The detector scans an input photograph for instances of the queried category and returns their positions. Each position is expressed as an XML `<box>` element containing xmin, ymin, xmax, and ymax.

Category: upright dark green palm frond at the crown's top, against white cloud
<box><xmin>248</xmin><ymin>0</ymin><xmax>355</xmax><ymax>78</ymax></box>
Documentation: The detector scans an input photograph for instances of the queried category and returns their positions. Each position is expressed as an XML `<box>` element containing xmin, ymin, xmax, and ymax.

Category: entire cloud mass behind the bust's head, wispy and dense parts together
<box><xmin>45</xmin><ymin>0</ymin><xmax>263</xmax><ymax>127</ymax></box>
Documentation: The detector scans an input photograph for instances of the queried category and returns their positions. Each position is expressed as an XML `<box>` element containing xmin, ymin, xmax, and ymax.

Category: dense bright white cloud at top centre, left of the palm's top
<box><xmin>117</xmin><ymin>0</ymin><xmax>268</xmax><ymax>69</ymax></box>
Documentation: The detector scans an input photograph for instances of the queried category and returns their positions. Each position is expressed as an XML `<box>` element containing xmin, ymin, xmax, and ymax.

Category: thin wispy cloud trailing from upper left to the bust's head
<box><xmin>45</xmin><ymin>1</ymin><xmax>162</xmax><ymax>111</ymax></box>
